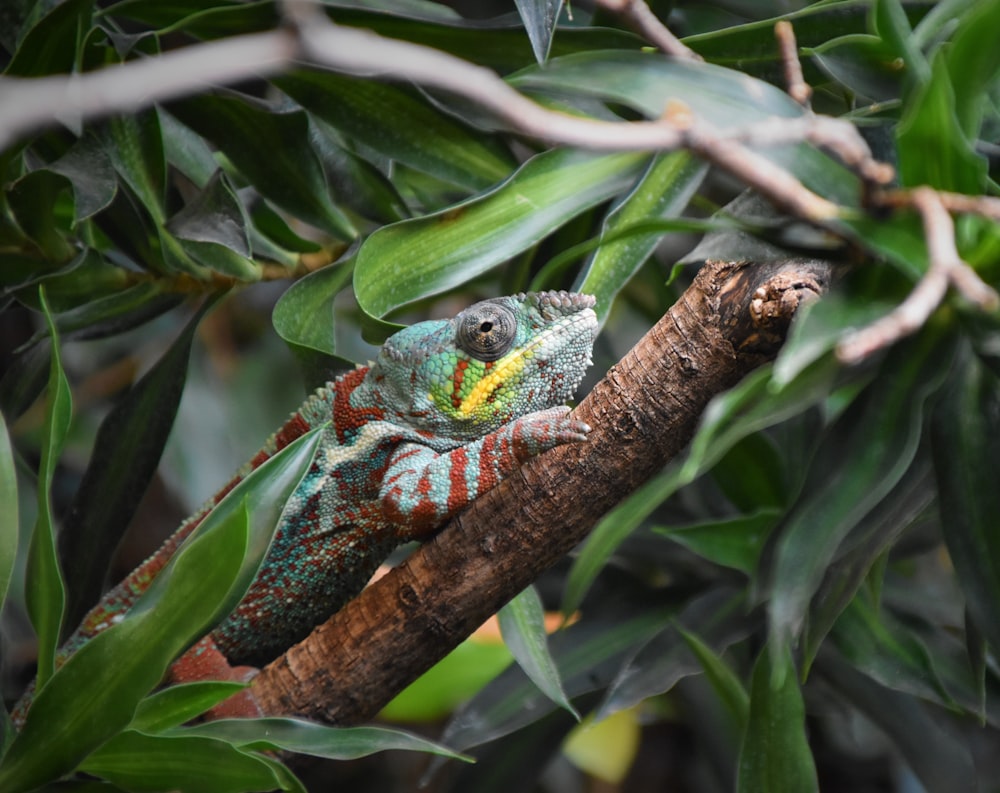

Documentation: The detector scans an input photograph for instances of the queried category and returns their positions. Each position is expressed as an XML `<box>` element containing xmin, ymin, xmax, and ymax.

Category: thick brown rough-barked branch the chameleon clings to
<box><xmin>251</xmin><ymin>260</ymin><xmax>831</xmax><ymax>725</ymax></box>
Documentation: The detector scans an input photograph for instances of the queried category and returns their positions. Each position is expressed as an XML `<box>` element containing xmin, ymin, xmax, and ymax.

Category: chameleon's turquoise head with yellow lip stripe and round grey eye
<box><xmin>370</xmin><ymin>292</ymin><xmax>597</xmax><ymax>439</ymax></box>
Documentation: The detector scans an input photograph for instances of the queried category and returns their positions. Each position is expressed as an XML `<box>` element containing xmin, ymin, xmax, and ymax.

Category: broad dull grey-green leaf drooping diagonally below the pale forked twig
<box><xmin>769</xmin><ymin>332</ymin><xmax>951</xmax><ymax>644</ymax></box>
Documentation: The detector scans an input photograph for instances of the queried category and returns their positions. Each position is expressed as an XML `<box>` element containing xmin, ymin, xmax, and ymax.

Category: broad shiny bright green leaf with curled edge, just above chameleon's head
<box><xmin>354</xmin><ymin>149</ymin><xmax>647</xmax><ymax>317</ymax></box>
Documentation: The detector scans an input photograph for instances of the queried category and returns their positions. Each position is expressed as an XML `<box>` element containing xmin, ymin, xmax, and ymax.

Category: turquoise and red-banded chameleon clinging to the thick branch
<box><xmin>18</xmin><ymin>291</ymin><xmax>598</xmax><ymax>717</ymax></box>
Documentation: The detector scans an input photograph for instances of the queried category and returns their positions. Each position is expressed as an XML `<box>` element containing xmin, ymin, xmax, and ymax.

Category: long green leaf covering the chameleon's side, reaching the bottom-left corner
<box><xmin>0</xmin><ymin>429</ymin><xmax>322</xmax><ymax>792</ymax></box>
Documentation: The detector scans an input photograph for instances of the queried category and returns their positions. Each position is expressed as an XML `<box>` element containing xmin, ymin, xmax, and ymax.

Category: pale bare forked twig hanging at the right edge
<box><xmin>837</xmin><ymin>187</ymin><xmax>1000</xmax><ymax>363</ymax></box>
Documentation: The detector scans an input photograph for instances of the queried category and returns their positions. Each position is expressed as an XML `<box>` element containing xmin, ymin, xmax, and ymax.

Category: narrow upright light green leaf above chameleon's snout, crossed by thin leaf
<box><xmin>573</xmin><ymin>151</ymin><xmax>708</xmax><ymax>322</ymax></box>
